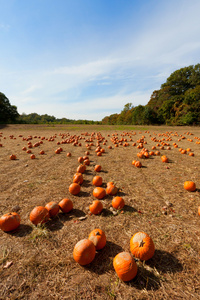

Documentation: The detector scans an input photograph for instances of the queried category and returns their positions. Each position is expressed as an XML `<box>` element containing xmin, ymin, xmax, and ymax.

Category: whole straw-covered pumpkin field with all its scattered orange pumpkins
<box><xmin>0</xmin><ymin>124</ymin><xmax>200</xmax><ymax>299</ymax></box>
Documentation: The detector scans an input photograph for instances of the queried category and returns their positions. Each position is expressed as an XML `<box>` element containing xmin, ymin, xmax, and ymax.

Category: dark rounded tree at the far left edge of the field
<box><xmin>0</xmin><ymin>93</ymin><xmax>19</xmax><ymax>124</ymax></box>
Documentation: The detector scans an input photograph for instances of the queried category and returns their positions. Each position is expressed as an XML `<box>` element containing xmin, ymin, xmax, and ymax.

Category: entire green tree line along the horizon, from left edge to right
<box><xmin>0</xmin><ymin>64</ymin><xmax>200</xmax><ymax>125</ymax></box>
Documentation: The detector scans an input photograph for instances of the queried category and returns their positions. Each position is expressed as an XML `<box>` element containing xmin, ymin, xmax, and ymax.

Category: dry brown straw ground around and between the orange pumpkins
<box><xmin>0</xmin><ymin>125</ymin><xmax>200</xmax><ymax>300</ymax></box>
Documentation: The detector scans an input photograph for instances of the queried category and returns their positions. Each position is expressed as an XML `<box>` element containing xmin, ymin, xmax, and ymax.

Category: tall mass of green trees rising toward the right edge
<box><xmin>102</xmin><ymin>64</ymin><xmax>200</xmax><ymax>125</ymax></box>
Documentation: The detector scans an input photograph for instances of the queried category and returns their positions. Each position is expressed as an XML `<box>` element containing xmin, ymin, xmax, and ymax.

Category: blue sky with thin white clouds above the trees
<box><xmin>0</xmin><ymin>0</ymin><xmax>200</xmax><ymax>120</ymax></box>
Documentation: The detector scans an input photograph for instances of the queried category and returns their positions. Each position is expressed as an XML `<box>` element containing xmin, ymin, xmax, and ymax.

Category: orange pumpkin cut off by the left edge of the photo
<box><xmin>0</xmin><ymin>212</ymin><xmax>21</xmax><ymax>231</ymax></box>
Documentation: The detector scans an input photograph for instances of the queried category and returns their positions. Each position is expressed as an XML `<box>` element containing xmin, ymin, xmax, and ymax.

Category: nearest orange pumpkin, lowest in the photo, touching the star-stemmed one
<box><xmin>113</xmin><ymin>252</ymin><xmax>138</xmax><ymax>281</ymax></box>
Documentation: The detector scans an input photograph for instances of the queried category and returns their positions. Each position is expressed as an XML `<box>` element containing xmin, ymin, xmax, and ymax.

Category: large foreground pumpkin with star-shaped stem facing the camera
<box><xmin>130</xmin><ymin>232</ymin><xmax>155</xmax><ymax>260</ymax></box>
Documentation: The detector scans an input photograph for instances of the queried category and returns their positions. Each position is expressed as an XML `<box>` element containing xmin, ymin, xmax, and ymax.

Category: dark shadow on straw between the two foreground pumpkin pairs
<box><xmin>84</xmin><ymin>241</ymin><xmax>124</xmax><ymax>275</ymax></box>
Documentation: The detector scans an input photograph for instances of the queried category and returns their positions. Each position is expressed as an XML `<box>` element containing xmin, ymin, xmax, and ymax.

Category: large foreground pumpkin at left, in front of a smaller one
<box><xmin>73</xmin><ymin>239</ymin><xmax>96</xmax><ymax>266</ymax></box>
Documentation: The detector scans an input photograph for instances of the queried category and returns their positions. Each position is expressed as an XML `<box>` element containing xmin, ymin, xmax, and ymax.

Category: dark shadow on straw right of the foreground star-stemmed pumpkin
<box><xmin>146</xmin><ymin>249</ymin><xmax>183</xmax><ymax>274</ymax></box>
